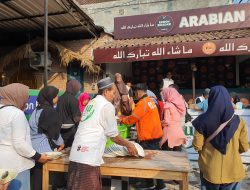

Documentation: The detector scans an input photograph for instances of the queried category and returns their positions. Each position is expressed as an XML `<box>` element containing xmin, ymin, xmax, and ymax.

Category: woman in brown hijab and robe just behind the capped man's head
<box><xmin>114</xmin><ymin>73</ymin><xmax>132</xmax><ymax>116</ymax></box>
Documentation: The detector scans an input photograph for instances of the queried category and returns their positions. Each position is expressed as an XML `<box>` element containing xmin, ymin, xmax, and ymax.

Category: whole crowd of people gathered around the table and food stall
<box><xmin>0</xmin><ymin>73</ymin><xmax>249</xmax><ymax>190</ymax></box>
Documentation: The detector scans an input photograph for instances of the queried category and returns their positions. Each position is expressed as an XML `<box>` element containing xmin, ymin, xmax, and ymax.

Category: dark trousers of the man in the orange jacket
<box><xmin>139</xmin><ymin>139</ymin><xmax>165</xmax><ymax>187</ymax></box>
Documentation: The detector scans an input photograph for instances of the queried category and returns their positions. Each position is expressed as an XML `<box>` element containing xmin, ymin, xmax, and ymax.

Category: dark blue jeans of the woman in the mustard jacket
<box><xmin>200</xmin><ymin>173</ymin><xmax>241</xmax><ymax>190</ymax></box>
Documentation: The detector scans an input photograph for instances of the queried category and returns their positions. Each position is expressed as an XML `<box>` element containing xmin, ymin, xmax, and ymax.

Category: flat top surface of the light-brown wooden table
<box><xmin>48</xmin><ymin>150</ymin><xmax>191</xmax><ymax>172</ymax></box>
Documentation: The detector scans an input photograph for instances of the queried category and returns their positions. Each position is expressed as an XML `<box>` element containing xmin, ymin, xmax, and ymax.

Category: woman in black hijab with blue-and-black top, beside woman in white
<box><xmin>29</xmin><ymin>86</ymin><xmax>64</xmax><ymax>190</ymax></box>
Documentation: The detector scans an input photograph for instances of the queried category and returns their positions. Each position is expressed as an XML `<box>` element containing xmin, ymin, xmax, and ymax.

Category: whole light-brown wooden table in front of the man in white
<box><xmin>43</xmin><ymin>150</ymin><xmax>191</xmax><ymax>190</ymax></box>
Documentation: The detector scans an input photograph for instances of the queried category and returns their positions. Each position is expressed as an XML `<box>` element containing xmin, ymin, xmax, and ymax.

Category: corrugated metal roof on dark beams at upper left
<box><xmin>0</xmin><ymin>0</ymin><xmax>102</xmax><ymax>44</ymax></box>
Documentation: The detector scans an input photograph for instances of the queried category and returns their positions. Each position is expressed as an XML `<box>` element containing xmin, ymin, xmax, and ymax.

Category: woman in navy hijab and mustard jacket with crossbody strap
<box><xmin>192</xmin><ymin>86</ymin><xmax>249</xmax><ymax>190</ymax></box>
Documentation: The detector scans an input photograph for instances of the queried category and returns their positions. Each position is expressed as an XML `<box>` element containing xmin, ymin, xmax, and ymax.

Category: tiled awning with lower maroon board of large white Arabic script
<box><xmin>94</xmin><ymin>28</ymin><xmax>250</xmax><ymax>64</ymax></box>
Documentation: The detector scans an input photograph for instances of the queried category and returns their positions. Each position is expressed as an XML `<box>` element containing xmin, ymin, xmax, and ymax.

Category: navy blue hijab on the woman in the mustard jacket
<box><xmin>192</xmin><ymin>86</ymin><xmax>240</xmax><ymax>154</ymax></box>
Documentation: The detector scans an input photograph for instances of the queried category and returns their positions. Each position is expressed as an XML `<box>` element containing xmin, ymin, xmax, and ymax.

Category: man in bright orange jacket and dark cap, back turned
<box><xmin>121</xmin><ymin>83</ymin><xmax>166</xmax><ymax>190</ymax></box>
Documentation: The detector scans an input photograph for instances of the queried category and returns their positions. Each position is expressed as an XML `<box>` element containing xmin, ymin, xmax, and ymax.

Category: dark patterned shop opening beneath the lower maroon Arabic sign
<box><xmin>132</xmin><ymin>56</ymin><xmax>235</xmax><ymax>92</ymax></box>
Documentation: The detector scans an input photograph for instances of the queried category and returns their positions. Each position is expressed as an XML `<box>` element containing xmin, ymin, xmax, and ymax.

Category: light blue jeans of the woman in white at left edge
<box><xmin>8</xmin><ymin>170</ymin><xmax>30</xmax><ymax>190</ymax></box>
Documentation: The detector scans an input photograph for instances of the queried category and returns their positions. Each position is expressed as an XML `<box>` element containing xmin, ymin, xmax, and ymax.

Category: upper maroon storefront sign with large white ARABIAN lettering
<box><xmin>114</xmin><ymin>4</ymin><xmax>250</xmax><ymax>39</ymax></box>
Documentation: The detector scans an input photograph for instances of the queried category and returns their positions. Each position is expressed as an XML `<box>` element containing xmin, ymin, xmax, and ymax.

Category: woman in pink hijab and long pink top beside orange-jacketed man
<box><xmin>160</xmin><ymin>87</ymin><xmax>186</xmax><ymax>151</ymax></box>
